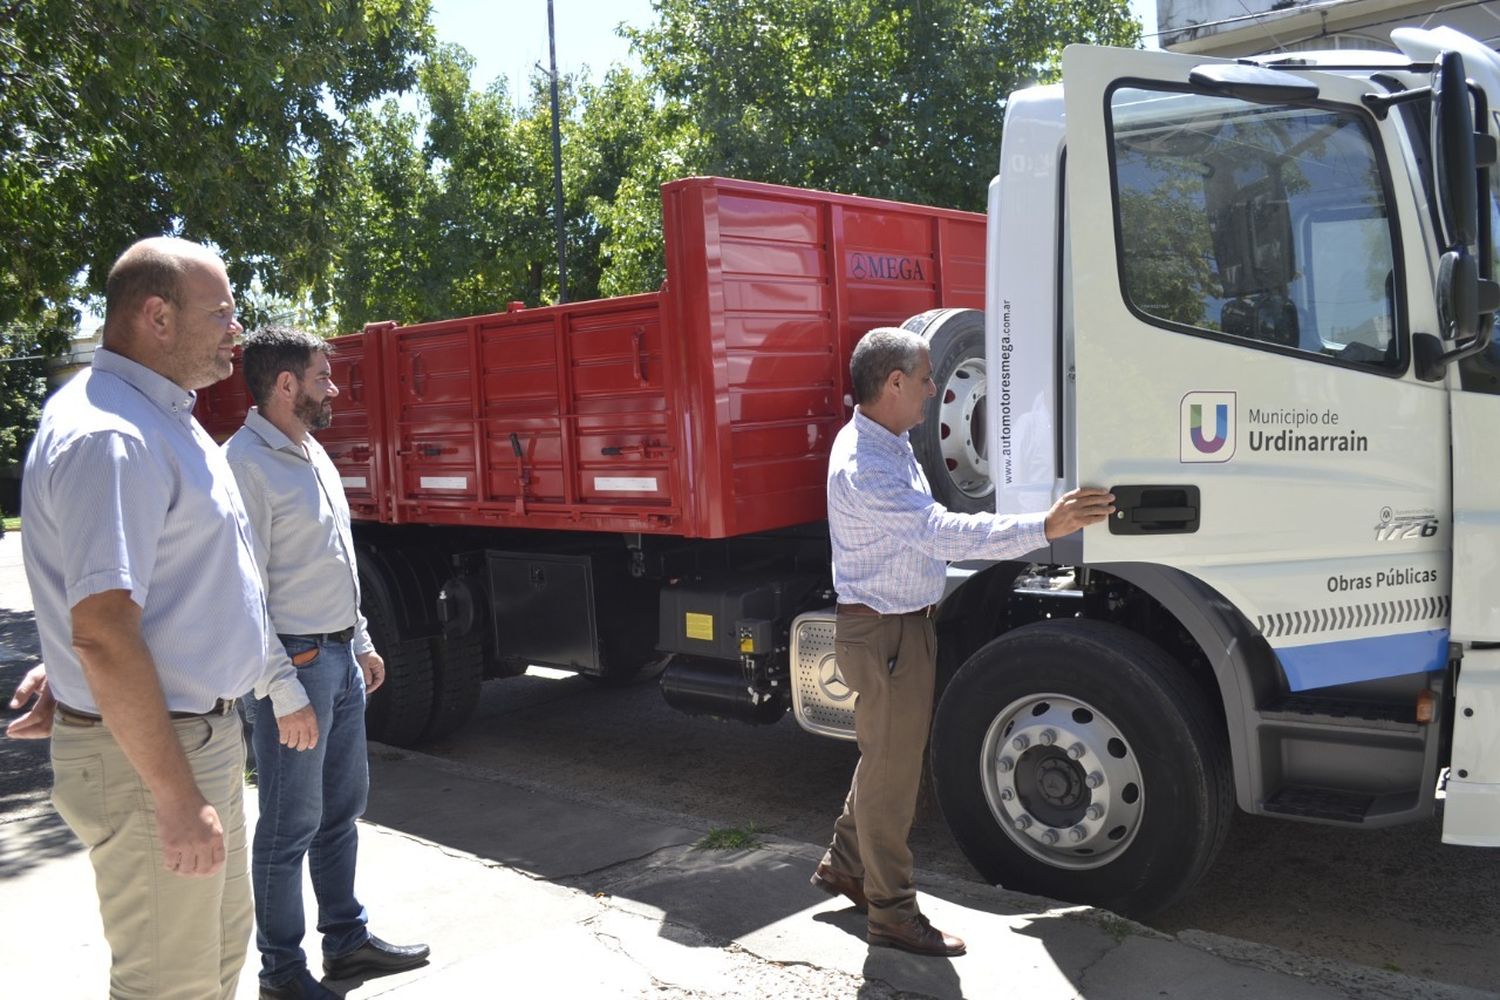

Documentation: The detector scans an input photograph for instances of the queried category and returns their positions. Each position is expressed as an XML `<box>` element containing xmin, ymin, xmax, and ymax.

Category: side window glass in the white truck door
<box><xmin>1110</xmin><ymin>87</ymin><xmax>1406</xmax><ymax>372</ymax></box>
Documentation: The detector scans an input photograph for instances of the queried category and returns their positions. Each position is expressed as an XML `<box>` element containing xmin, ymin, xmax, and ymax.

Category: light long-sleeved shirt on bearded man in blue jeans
<box><xmin>224</xmin><ymin>406</ymin><xmax>375</xmax><ymax>717</ymax></box>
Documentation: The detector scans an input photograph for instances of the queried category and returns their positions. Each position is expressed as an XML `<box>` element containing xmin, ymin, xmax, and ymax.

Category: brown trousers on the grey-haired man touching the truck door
<box><xmin>824</xmin><ymin>615</ymin><xmax>938</xmax><ymax>924</ymax></box>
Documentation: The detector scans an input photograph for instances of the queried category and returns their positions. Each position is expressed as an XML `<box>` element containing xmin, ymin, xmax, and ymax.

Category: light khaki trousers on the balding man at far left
<box><xmin>53</xmin><ymin>712</ymin><xmax>252</xmax><ymax>1000</ymax></box>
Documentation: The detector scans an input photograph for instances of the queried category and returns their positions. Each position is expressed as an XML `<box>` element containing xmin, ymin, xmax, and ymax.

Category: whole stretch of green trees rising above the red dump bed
<box><xmin>332</xmin><ymin>0</ymin><xmax>1139</xmax><ymax>330</ymax></box>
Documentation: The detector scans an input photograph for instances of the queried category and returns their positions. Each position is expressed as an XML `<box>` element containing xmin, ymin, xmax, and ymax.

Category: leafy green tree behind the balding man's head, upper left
<box><xmin>0</xmin><ymin>0</ymin><xmax>431</xmax><ymax>335</ymax></box>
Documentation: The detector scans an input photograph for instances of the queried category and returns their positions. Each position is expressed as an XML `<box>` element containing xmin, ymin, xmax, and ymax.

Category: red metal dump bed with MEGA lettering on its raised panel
<box><xmin>198</xmin><ymin>177</ymin><xmax>984</xmax><ymax>538</ymax></box>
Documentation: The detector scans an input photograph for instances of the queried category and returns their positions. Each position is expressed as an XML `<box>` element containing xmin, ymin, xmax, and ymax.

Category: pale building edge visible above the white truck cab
<box><xmin>1157</xmin><ymin>0</ymin><xmax>1500</xmax><ymax>55</ymax></box>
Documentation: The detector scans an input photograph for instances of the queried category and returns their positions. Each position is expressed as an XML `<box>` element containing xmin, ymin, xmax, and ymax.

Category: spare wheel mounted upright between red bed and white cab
<box><xmin>902</xmin><ymin>309</ymin><xmax>995</xmax><ymax>514</ymax></box>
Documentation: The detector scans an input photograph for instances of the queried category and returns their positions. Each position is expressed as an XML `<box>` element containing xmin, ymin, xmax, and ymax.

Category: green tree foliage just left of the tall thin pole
<box><xmin>332</xmin><ymin>46</ymin><xmax>554</xmax><ymax>330</ymax></box>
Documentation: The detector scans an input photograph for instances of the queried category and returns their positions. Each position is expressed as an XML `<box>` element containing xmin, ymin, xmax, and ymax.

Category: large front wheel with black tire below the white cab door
<box><xmin>932</xmin><ymin>619</ymin><xmax>1233</xmax><ymax>918</ymax></box>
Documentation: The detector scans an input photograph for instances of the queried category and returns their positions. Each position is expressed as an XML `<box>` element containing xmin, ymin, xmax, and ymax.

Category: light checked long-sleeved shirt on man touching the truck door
<box><xmin>828</xmin><ymin>408</ymin><xmax>1047</xmax><ymax>615</ymax></box>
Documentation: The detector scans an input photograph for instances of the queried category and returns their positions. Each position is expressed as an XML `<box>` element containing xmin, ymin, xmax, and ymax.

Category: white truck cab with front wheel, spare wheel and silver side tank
<box><xmin>791</xmin><ymin>28</ymin><xmax>1500</xmax><ymax>913</ymax></box>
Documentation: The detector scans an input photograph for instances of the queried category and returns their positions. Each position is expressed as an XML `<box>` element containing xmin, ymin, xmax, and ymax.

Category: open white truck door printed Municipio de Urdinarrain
<box><xmin>1064</xmin><ymin>46</ymin><xmax>1452</xmax><ymax>691</ymax></box>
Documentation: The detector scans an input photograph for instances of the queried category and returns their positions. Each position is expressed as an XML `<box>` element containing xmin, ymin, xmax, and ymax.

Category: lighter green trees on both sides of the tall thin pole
<box><xmin>330</xmin><ymin>46</ymin><xmax>677</xmax><ymax>330</ymax></box>
